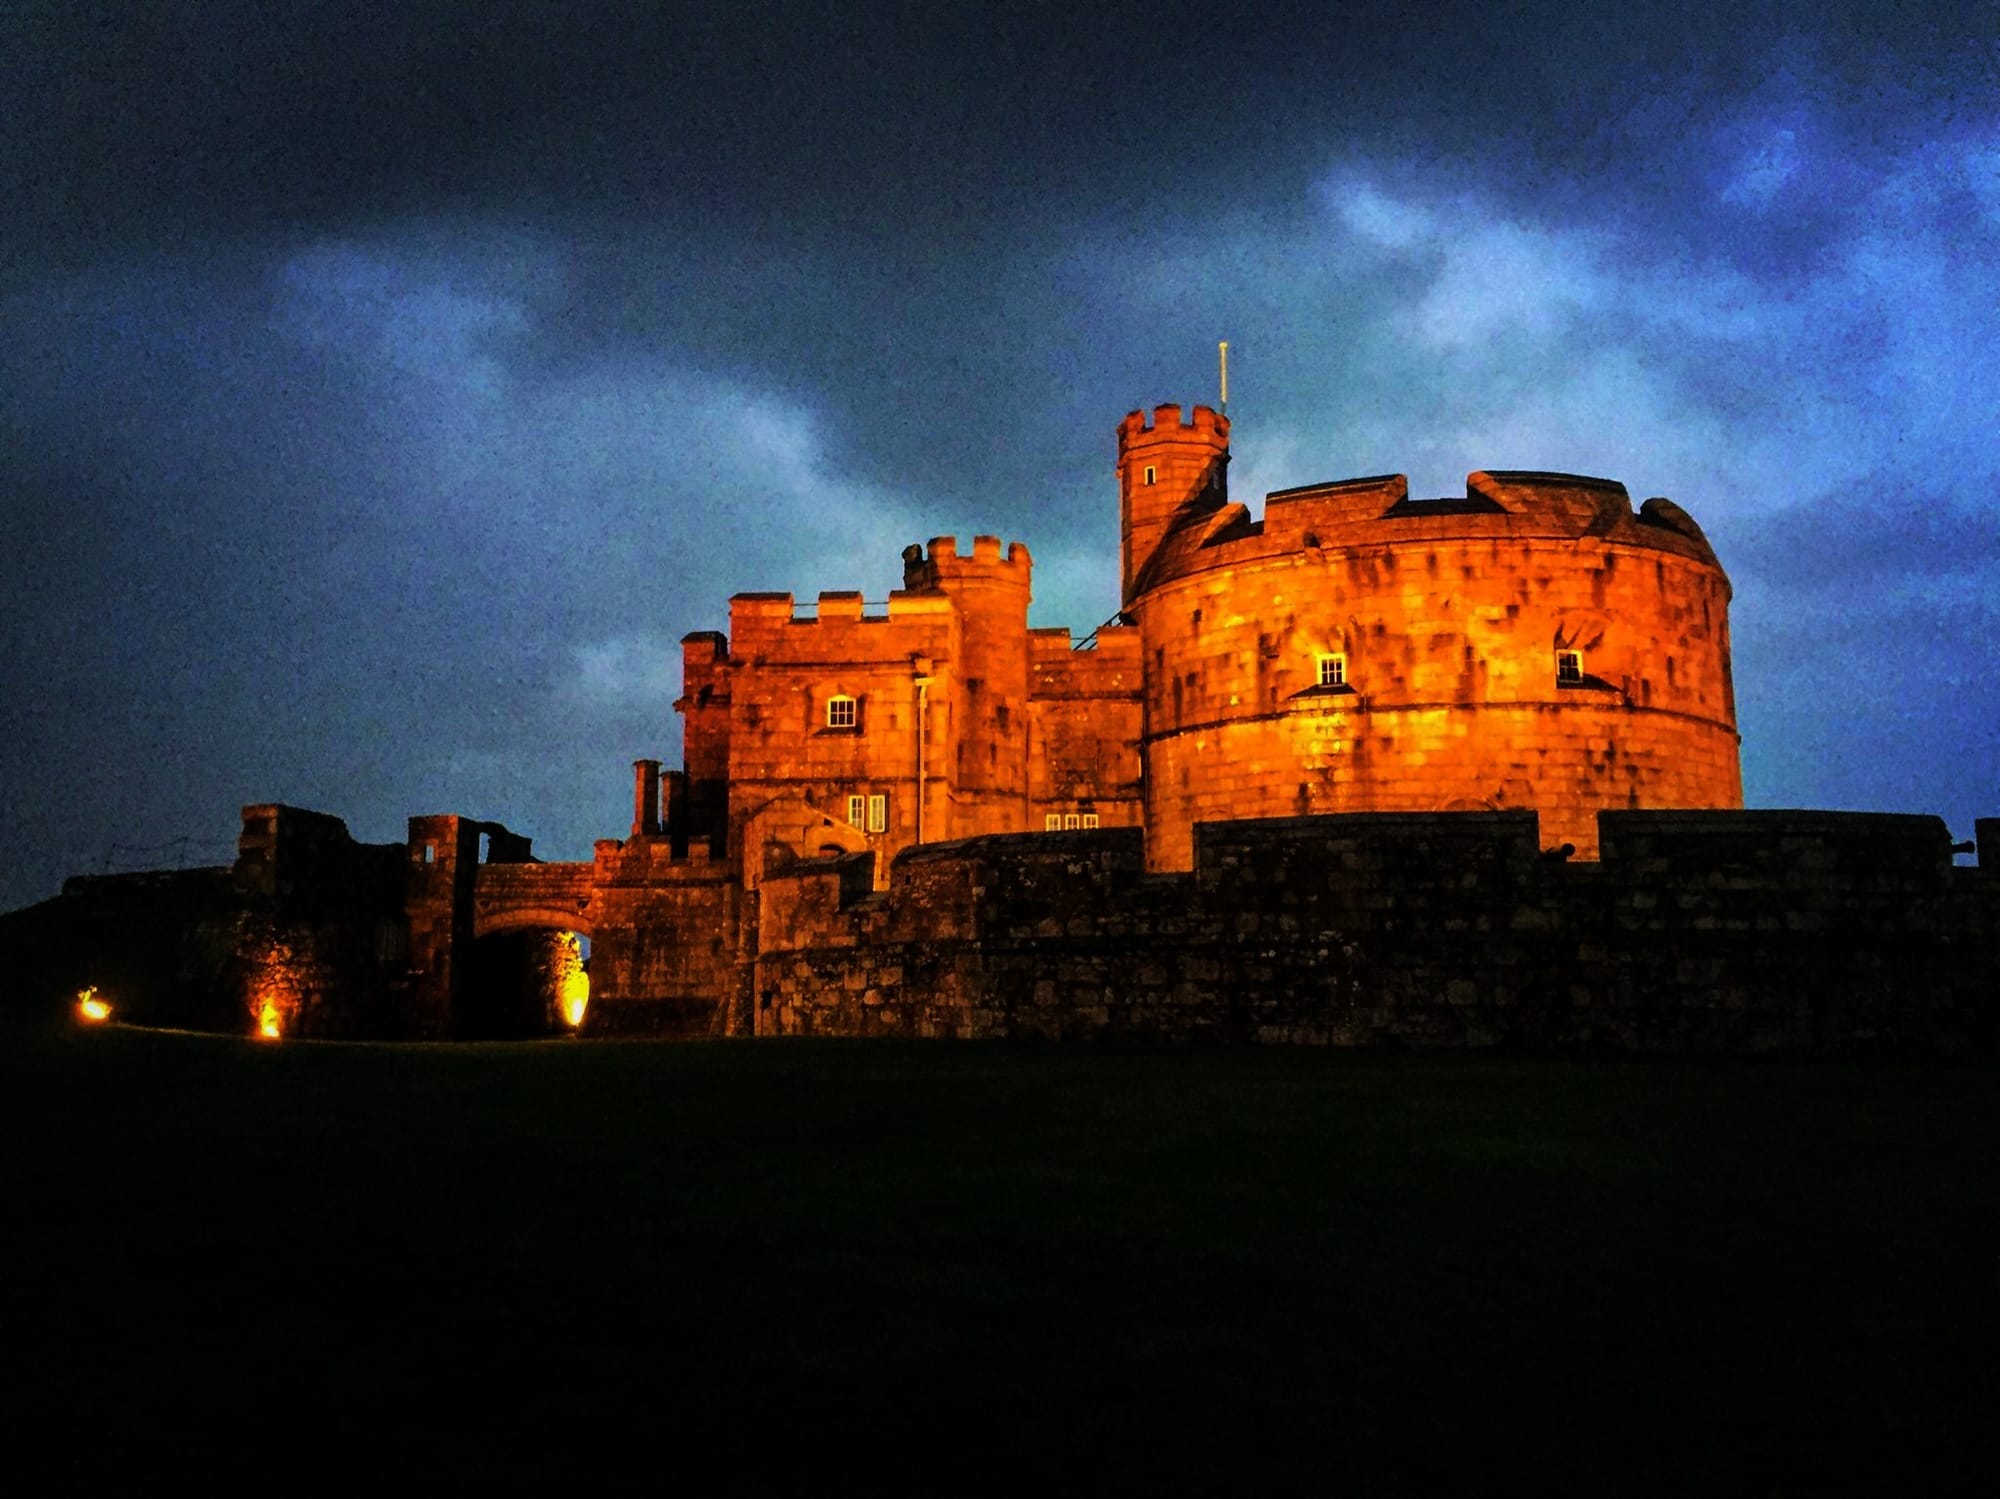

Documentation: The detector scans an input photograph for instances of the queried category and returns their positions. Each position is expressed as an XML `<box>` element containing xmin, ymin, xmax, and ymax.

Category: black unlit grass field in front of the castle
<box><xmin>0</xmin><ymin>1027</ymin><xmax>2000</xmax><ymax>1495</ymax></box>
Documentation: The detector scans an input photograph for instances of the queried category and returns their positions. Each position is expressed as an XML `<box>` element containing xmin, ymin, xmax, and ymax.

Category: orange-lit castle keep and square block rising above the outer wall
<box><xmin>680</xmin><ymin>406</ymin><xmax>1742</xmax><ymax>885</ymax></box>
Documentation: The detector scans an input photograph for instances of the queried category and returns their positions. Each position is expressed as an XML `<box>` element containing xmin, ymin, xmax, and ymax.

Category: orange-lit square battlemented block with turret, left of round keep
<box><xmin>672</xmin><ymin>536</ymin><xmax>1142</xmax><ymax>885</ymax></box>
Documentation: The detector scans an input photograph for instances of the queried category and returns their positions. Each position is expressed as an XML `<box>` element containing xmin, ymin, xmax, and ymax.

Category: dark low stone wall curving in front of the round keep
<box><xmin>752</xmin><ymin>811</ymin><xmax>2000</xmax><ymax>1055</ymax></box>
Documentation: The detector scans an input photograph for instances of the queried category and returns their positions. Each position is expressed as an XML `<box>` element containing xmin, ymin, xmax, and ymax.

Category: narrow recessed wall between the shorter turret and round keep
<box><xmin>1026</xmin><ymin>626</ymin><xmax>1144</xmax><ymax>831</ymax></box>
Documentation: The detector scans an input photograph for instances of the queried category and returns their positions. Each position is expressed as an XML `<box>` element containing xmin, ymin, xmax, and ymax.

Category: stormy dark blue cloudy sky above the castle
<box><xmin>0</xmin><ymin>0</ymin><xmax>2000</xmax><ymax>907</ymax></box>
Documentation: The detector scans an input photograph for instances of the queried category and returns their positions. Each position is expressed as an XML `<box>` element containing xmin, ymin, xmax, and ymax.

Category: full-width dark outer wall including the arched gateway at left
<box><xmin>0</xmin><ymin>805</ymin><xmax>2000</xmax><ymax>1057</ymax></box>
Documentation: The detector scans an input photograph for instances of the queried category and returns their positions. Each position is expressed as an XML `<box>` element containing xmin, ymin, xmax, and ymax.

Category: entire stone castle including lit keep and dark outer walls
<box><xmin>20</xmin><ymin>406</ymin><xmax>2000</xmax><ymax>1051</ymax></box>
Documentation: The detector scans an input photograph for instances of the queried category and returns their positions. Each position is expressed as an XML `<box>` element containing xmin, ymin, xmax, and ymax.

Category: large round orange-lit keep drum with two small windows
<box><xmin>1130</xmin><ymin>474</ymin><xmax>1742</xmax><ymax>869</ymax></box>
